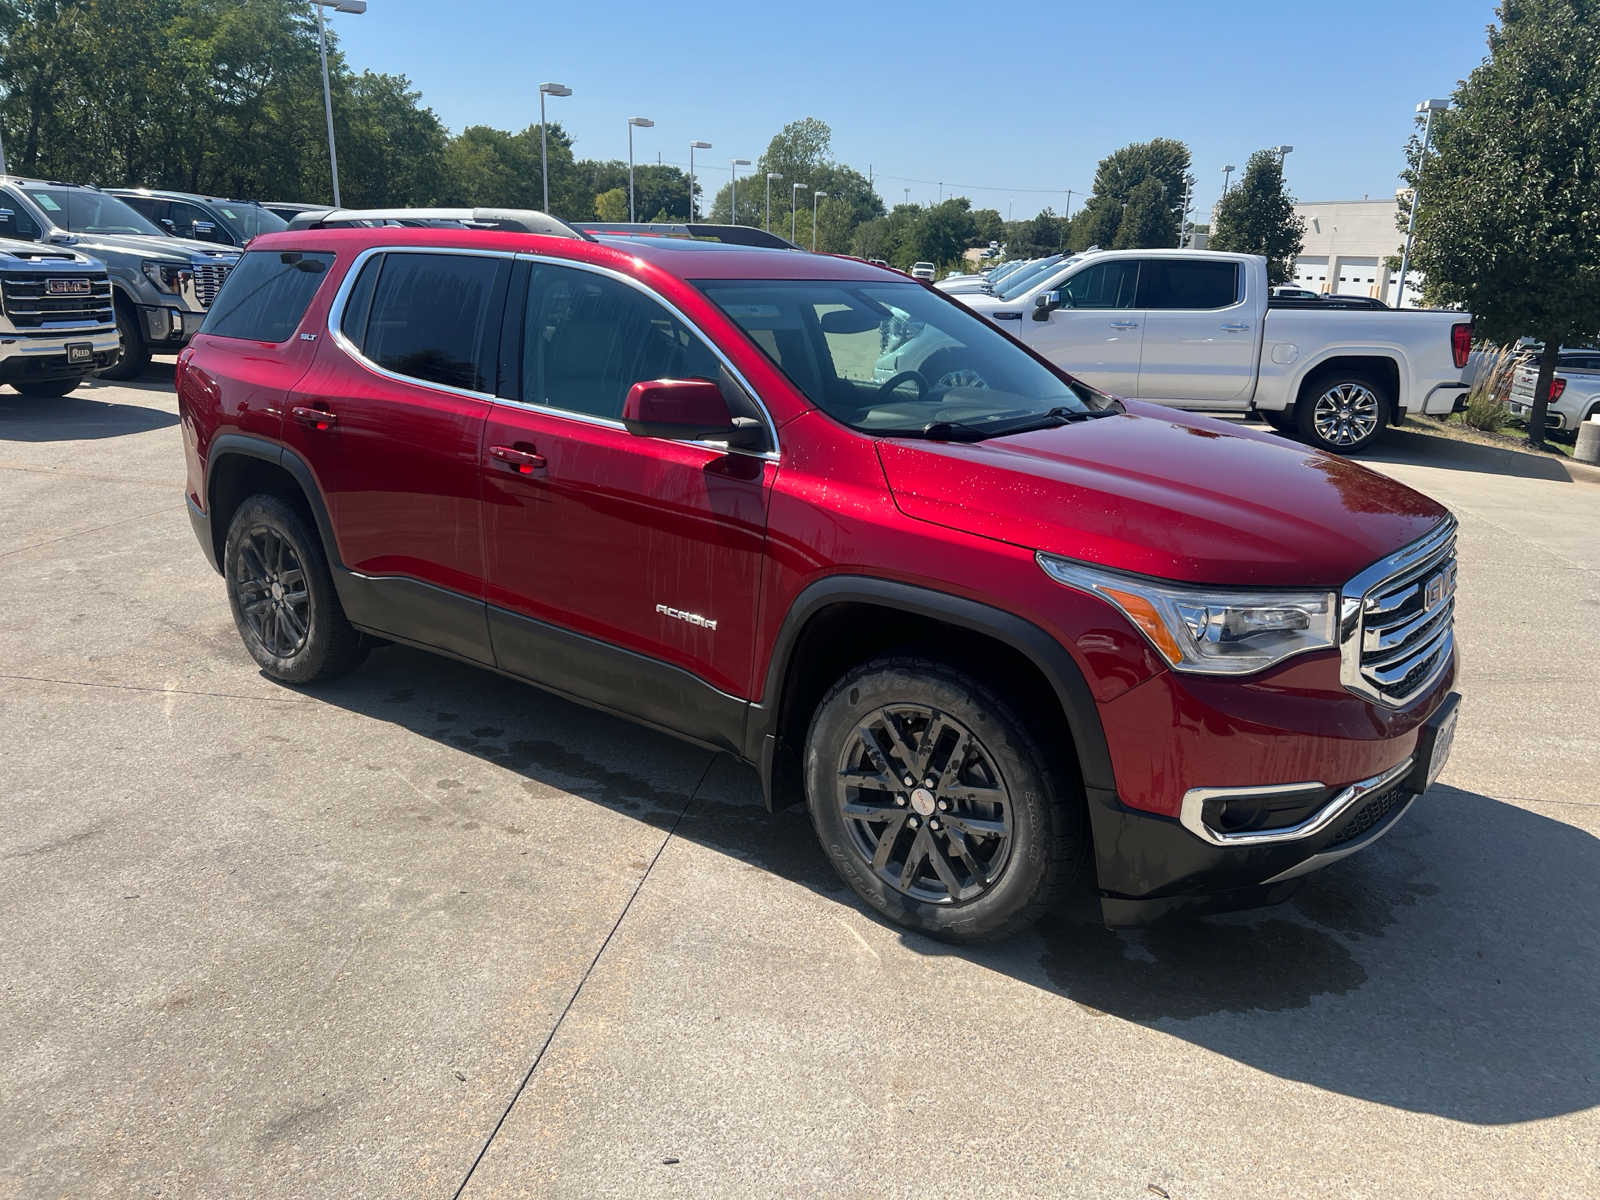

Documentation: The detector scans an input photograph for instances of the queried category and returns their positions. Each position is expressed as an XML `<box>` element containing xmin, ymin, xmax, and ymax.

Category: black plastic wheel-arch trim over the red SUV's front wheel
<box><xmin>744</xmin><ymin>574</ymin><xmax>1115</xmax><ymax>808</ymax></box>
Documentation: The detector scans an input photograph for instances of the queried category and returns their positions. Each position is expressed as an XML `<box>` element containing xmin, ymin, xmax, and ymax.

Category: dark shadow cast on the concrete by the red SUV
<box><xmin>307</xmin><ymin>648</ymin><xmax>1600</xmax><ymax>1125</ymax></box>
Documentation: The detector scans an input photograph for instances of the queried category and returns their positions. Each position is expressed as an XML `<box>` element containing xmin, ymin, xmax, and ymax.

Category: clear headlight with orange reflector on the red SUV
<box><xmin>1037</xmin><ymin>554</ymin><xmax>1339</xmax><ymax>675</ymax></box>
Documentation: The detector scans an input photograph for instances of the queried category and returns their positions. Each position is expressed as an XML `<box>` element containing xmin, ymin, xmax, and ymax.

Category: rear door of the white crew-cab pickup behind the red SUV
<box><xmin>1136</xmin><ymin>256</ymin><xmax>1266</xmax><ymax>411</ymax></box>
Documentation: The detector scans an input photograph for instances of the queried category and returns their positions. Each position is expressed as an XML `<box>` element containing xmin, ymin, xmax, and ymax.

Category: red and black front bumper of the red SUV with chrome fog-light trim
<box><xmin>1088</xmin><ymin>662</ymin><xmax>1459</xmax><ymax>926</ymax></box>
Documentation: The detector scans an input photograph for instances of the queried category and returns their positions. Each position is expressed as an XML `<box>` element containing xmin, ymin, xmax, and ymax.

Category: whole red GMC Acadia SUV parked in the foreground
<box><xmin>178</xmin><ymin>214</ymin><xmax>1456</xmax><ymax>939</ymax></box>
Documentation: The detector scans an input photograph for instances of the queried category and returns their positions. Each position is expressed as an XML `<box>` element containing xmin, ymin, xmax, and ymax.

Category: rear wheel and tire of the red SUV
<box><xmin>222</xmin><ymin>494</ymin><xmax>368</xmax><ymax>683</ymax></box>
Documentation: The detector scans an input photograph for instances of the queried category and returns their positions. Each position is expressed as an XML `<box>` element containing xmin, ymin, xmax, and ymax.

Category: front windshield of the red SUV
<box><xmin>696</xmin><ymin>280</ymin><xmax>1106</xmax><ymax>440</ymax></box>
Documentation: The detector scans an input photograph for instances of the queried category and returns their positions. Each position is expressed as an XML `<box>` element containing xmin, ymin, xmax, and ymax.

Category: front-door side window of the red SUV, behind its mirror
<box><xmin>522</xmin><ymin>266</ymin><xmax>722</xmax><ymax>419</ymax></box>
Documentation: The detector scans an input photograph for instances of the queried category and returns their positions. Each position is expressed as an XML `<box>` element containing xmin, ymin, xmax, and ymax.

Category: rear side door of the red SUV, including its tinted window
<box><xmin>283</xmin><ymin>248</ymin><xmax>510</xmax><ymax>662</ymax></box>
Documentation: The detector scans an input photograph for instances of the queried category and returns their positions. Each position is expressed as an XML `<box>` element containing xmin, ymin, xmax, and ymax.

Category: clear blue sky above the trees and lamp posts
<box><xmin>331</xmin><ymin>0</ymin><xmax>1494</xmax><ymax>219</ymax></box>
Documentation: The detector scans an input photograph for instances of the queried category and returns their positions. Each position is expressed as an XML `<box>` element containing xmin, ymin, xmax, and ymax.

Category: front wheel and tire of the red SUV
<box><xmin>805</xmin><ymin>658</ymin><xmax>1090</xmax><ymax>942</ymax></box>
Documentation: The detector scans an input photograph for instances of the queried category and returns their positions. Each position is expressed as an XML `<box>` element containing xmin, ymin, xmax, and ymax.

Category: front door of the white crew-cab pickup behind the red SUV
<box><xmin>1006</xmin><ymin>259</ymin><xmax>1144</xmax><ymax>395</ymax></box>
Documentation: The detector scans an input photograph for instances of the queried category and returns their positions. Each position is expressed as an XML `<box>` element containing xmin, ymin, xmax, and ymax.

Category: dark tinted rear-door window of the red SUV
<box><xmin>362</xmin><ymin>253</ymin><xmax>507</xmax><ymax>392</ymax></box>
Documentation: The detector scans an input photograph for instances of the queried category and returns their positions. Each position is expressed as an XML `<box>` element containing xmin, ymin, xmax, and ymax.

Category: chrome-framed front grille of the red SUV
<box><xmin>1341</xmin><ymin>518</ymin><xmax>1456</xmax><ymax>706</ymax></box>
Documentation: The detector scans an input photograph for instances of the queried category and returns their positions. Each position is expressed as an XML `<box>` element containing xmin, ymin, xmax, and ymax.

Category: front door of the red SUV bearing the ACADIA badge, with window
<box><xmin>482</xmin><ymin>262</ymin><xmax>778</xmax><ymax>742</ymax></box>
